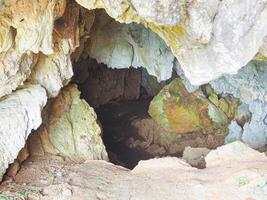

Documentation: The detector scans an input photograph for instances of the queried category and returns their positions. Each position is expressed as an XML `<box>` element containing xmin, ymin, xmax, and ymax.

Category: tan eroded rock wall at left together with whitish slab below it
<box><xmin>0</xmin><ymin>0</ymin><xmax>82</xmax><ymax>180</ymax></box>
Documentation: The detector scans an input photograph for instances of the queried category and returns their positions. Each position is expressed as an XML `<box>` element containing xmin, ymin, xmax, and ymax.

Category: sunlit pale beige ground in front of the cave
<box><xmin>0</xmin><ymin>143</ymin><xmax>267</xmax><ymax>200</ymax></box>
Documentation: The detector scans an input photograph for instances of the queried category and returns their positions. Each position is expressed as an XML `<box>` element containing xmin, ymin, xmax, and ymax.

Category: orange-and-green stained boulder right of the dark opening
<box><xmin>149</xmin><ymin>79</ymin><xmax>212</xmax><ymax>133</ymax></box>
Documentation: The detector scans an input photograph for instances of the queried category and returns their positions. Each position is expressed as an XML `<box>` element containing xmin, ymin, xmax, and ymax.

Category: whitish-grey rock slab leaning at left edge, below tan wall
<box><xmin>0</xmin><ymin>85</ymin><xmax>47</xmax><ymax>179</ymax></box>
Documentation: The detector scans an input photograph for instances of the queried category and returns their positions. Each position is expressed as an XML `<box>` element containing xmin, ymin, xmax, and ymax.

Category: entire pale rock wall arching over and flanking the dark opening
<box><xmin>0</xmin><ymin>0</ymin><xmax>267</xmax><ymax>181</ymax></box>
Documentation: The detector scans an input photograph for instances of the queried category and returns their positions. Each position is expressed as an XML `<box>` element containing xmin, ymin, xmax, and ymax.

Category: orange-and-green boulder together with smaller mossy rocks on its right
<box><xmin>149</xmin><ymin>79</ymin><xmax>239</xmax><ymax>134</ymax></box>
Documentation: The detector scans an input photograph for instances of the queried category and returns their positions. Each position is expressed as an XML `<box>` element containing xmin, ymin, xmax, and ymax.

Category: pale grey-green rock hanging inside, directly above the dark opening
<box><xmin>88</xmin><ymin>12</ymin><xmax>174</xmax><ymax>81</ymax></box>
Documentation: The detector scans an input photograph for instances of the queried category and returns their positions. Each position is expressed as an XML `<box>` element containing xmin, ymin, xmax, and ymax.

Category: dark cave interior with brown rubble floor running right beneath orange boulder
<box><xmin>72</xmin><ymin>58</ymin><xmax>225</xmax><ymax>169</ymax></box>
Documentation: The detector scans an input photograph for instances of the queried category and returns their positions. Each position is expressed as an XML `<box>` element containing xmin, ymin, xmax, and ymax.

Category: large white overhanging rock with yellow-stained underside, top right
<box><xmin>76</xmin><ymin>0</ymin><xmax>267</xmax><ymax>85</ymax></box>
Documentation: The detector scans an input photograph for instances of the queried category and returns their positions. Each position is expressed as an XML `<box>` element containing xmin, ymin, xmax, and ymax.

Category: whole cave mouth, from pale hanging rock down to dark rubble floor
<box><xmin>69</xmin><ymin>6</ymin><xmax>225</xmax><ymax>168</ymax></box>
